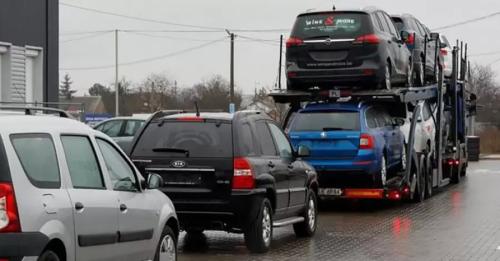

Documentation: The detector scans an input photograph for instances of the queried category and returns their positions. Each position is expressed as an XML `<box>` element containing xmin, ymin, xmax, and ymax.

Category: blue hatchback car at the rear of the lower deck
<box><xmin>287</xmin><ymin>102</ymin><xmax>406</xmax><ymax>197</ymax></box>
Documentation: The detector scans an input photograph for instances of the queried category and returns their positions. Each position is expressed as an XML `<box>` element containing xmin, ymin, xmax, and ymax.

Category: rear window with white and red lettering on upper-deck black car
<box><xmin>292</xmin><ymin>13</ymin><xmax>369</xmax><ymax>39</ymax></box>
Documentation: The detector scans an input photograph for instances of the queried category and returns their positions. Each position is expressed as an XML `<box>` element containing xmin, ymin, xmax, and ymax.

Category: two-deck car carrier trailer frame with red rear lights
<box><xmin>270</xmin><ymin>40</ymin><xmax>475</xmax><ymax>202</ymax></box>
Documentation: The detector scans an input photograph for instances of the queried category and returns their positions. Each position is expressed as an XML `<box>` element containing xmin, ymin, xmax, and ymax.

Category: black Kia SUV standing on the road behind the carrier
<box><xmin>130</xmin><ymin>112</ymin><xmax>318</xmax><ymax>252</ymax></box>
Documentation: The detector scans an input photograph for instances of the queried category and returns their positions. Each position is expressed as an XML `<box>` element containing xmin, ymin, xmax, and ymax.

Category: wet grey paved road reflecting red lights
<box><xmin>179</xmin><ymin>160</ymin><xmax>500</xmax><ymax>261</ymax></box>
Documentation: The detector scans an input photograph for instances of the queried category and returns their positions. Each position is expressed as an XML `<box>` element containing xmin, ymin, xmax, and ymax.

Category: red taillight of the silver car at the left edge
<box><xmin>0</xmin><ymin>183</ymin><xmax>21</xmax><ymax>233</ymax></box>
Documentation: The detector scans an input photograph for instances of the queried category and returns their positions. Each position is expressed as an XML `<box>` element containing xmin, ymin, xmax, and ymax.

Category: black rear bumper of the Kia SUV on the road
<box><xmin>174</xmin><ymin>189</ymin><xmax>266</xmax><ymax>231</ymax></box>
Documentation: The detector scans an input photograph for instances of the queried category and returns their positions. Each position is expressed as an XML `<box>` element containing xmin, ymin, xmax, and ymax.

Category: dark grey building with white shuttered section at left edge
<box><xmin>0</xmin><ymin>0</ymin><xmax>59</xmax><ymax>103</ymax></box>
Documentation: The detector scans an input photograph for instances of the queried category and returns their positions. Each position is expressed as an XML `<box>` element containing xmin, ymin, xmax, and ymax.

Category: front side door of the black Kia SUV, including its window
<box><xmin>268</xmin><ymin>123</ymin><xmax>307</xmax><ymax>211</ymax></box>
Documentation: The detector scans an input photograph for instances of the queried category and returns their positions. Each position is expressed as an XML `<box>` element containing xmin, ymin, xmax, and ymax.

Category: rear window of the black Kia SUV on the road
<box><xmin>133</xmin><ymin>121</ymin><xmax>233</xmax><ymax>158</ymax></box>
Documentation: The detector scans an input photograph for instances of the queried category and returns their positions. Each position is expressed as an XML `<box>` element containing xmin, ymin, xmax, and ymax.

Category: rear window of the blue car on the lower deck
<box><xmin>290</xmin><ymin>111</ymin><xmax>360</xmax><ymax>131</ymax></box>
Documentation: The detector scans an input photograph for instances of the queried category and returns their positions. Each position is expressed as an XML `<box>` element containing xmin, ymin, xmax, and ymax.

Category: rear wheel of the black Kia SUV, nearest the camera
<box><xmin>245</xmin><ymin>198</ymin><xmax>273</xmax><ymax>253</ymax></box>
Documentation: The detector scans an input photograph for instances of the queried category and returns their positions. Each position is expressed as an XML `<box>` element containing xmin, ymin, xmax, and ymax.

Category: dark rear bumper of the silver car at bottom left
<box><xmin>0</xmin><ymin>232</ymin><xmax>49</xmax><ymax>260</ymax></box>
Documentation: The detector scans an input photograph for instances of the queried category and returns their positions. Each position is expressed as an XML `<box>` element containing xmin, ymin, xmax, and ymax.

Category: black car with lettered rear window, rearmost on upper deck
<box><xmin>286</xmin><ymin>9</ymin><xmax>412</xmax><ymax>90</ymax></box>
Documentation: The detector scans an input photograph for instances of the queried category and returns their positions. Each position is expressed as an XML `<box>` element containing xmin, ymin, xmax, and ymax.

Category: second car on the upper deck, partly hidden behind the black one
<box><xmin>392</xmin><ymin>14</ymin><xmax>441</xmax><ymax>86</ymax></box>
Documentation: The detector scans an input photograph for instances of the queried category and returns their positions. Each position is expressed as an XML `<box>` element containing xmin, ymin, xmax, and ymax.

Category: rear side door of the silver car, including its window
<box><xmin>61</xmin><ymin>135</ymin><xmax>119</xmax><ymax>260</ymax></box>
